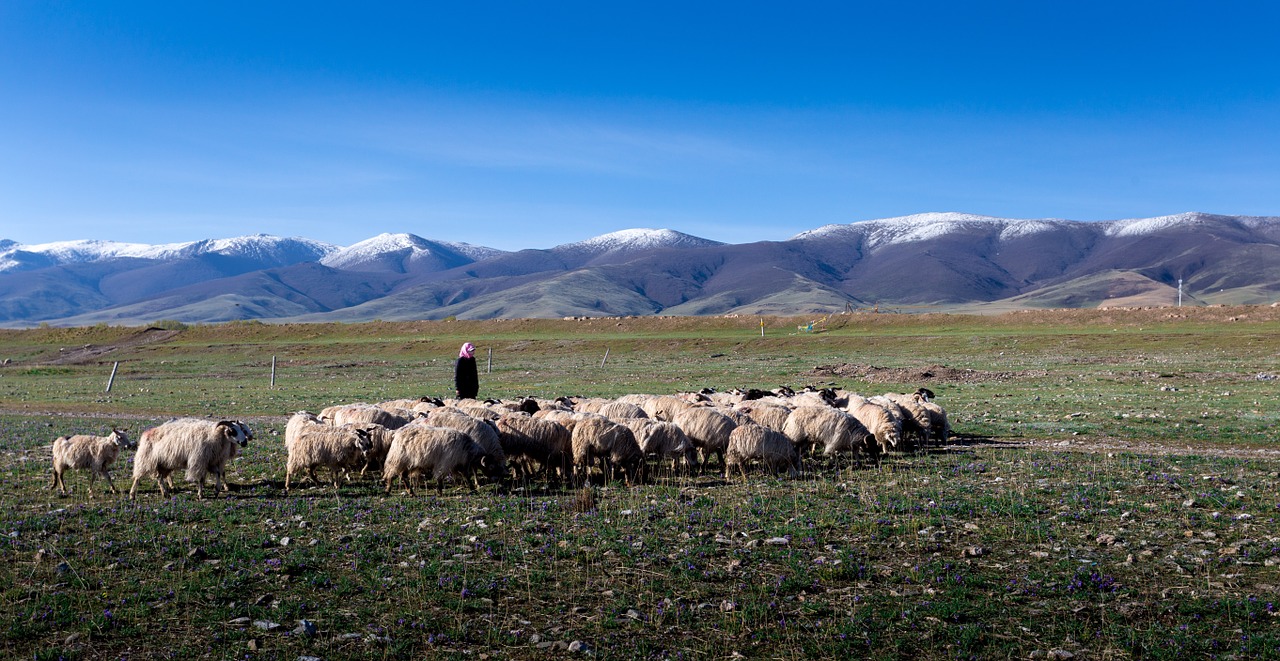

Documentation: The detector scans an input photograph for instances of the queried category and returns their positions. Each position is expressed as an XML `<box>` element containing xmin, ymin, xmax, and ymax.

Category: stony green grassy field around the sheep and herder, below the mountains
<box><xmin>0</xmin><ymin>307</ymin><xmax>1280</xmax><ymax>660</ymax></box>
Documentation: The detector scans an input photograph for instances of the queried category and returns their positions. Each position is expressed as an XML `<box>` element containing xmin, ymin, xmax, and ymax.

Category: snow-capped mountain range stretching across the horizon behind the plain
<box><xmin>0</xmin><ymin>213</ymin><xmax>1280</xmax><ymax>327</ymax></box>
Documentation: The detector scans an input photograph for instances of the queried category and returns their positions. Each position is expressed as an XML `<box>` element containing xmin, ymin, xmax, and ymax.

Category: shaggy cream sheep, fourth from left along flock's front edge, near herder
<box><xmin>383</xmin><ymin>424</ymin><xmax>504</xmax><ymax>496</ymax></box>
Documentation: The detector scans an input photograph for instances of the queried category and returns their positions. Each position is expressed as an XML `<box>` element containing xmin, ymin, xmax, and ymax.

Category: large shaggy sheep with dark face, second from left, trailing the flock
<box><xmin>129</xmin><ymin>418</ymin><xmax>253</xmax><ymax>500</ymax></box>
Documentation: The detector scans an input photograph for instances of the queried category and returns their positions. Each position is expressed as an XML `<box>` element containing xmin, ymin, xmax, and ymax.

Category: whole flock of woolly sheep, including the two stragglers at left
<box><xmin>50</xmin><ymin>388</ymin><xmax>951</xmax><ymax>500</ymax></box>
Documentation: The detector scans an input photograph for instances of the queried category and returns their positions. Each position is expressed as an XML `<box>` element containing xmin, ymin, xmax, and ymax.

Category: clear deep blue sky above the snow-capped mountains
<box><xmin>0</xmin><ymin>0</ymin><xmax>1280</xmax><ymax>250</ymax></box>
